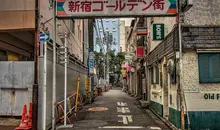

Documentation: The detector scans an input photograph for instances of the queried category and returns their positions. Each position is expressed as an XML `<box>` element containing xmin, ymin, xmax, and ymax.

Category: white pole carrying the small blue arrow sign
<box><xmin>42</xmin><ymin>42</ymin><xmax>47</xmax><ymax>130</ymax></box>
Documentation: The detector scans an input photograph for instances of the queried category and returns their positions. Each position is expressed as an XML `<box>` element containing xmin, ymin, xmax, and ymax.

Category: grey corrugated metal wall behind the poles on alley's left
<box><xmin>38</xmin><ymin>47</ymin><xmax>87</xmax><ymax>129</ymax></box>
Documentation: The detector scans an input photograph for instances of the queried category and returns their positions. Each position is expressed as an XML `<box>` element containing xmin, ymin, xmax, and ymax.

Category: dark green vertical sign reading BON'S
<box><xmin>153</xmin><ymin>24</ymin><xmax>164</xmax><ymax>40</ymax></box>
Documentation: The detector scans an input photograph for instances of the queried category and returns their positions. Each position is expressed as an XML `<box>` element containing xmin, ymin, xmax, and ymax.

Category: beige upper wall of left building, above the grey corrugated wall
<box><xmin>40</xmin><ymin>0</ymin><xmax>84</xmax><ymax>61</ymax></box>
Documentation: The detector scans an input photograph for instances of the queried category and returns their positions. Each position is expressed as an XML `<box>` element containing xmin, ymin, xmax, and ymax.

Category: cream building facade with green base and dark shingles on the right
<box><xmin>147</xmin><ymin>0</ymin><xmax>220</xmax><ymax>130</ymax></box>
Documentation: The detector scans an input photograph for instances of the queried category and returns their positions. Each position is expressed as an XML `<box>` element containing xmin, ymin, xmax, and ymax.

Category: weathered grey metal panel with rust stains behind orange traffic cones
<box><xmin>0</xmin><ymin>62</ymin><xmax>34</xmax><ymax>116</ymax></box>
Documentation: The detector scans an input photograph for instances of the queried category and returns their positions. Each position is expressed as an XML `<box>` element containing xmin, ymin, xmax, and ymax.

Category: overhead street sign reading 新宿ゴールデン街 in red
<box><xmin>57</xmin><ymin>0</ymin><xmax>177</xmax><ymax>17</ymax></box>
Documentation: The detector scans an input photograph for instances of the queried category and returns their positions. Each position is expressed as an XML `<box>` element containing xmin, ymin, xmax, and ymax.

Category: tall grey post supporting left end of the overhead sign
<box><xmin>52</xmin><ymin>0</ymin><xmax>56</xmax><ymax>130</ymax></box>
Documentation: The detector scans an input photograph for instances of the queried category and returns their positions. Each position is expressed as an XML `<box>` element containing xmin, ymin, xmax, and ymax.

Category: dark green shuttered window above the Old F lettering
<box><xmin>198</xmin><ymin>53</ymin><xmax>220</xmax><ymax>83</ymax></box>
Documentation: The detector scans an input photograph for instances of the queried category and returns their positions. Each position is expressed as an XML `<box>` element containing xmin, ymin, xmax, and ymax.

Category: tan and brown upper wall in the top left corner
<box><xmin>0</xmin><ymin>0</ymin><xmax>35</xmax><ymax>31</ymax></box>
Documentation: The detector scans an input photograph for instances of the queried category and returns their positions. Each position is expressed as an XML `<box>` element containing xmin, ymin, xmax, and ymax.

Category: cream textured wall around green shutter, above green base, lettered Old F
<box><xmin>183</xmin><ymin>51</ymin><xmax>220</xmax><ymax>111</ymax></box>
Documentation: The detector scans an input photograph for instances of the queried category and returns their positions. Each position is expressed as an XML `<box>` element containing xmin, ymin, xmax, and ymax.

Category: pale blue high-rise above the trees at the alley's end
<box><xmin>94</xmin><ymin>19</ymin><xmax>120</xmax><ymax>54</ymax></box>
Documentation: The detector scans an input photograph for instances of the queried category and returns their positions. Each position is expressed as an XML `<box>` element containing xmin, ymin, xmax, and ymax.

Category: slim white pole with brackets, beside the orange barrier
<box><xmin>64</xmin><ymin>32</ymin><xmax>67</xmax><ymax>126</ymax></box>
